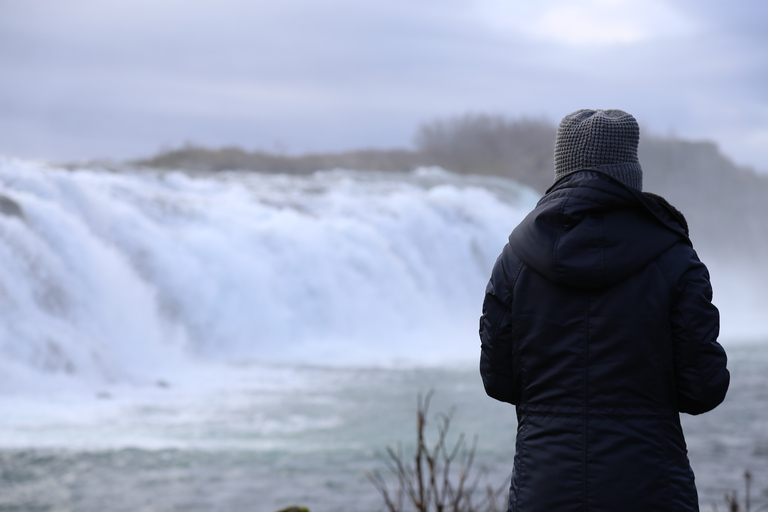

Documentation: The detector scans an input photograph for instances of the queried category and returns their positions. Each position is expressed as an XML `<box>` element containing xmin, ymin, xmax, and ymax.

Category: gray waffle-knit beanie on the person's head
<box><xmin>555</xmin><ymin>109</ymin><xmax>643</xmax><ymax>190</ymax></box>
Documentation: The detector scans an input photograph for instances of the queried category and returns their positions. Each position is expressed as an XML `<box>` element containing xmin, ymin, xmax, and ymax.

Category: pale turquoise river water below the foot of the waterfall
<box><xmin>0</xmin><ymin>344</ymin><xmax>768</xmax><ymax>512</ymax></box>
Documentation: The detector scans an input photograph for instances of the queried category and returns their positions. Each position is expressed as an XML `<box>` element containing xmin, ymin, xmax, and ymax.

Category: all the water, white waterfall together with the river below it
<box><xmin>0</xmin><ymin>158</ymin><xmax>768</xmax><ymax>512</ymax></box>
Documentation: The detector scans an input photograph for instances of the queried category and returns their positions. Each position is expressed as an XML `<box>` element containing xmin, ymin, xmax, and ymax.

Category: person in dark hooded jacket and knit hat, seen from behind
<box><xmin>480</xmin><ymin>109</ymin><xmax>730</xmax><ymax>512</ymax></box>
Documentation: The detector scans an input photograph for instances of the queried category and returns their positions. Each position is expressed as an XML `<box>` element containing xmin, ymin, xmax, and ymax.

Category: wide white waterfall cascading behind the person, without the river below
<box><xmin>0</xmin><ymin>160</ymin><xmax>536</xmax><ymax>392</ymax></box>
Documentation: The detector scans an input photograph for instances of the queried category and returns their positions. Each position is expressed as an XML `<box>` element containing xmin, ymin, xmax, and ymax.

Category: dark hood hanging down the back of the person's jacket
<box><xmin>509</xmin><ymin>171</ymin><xmax>691</xmax><ymax>288</ymax></box>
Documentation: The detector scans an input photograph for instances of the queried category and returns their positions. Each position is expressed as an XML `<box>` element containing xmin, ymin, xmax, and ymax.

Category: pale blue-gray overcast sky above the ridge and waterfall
<box><xmin>0</xmin><ymin>0</ymin><xmax>768</xmax><ymax>171</ymax></box>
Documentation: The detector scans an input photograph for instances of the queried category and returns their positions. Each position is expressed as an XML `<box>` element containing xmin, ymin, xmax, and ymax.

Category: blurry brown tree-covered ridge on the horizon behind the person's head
<box><xmin>134</xmin><ymin>114</ymin><xmax>768</xmax><ymax>265</ymax></box>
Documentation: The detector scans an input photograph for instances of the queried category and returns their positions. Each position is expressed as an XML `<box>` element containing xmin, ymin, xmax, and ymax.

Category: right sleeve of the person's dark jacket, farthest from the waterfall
<box><xmin>671</xmin><ymin>248</ymin><xmax>730</xmax><ymax>414</ymax></box>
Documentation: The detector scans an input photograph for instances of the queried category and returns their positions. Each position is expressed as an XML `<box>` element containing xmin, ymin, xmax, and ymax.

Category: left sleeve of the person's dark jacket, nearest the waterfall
<box><xmin>480</xmin><ymin>245</ymin><xmax>522</xmax><ymax>404</ymax></box>
